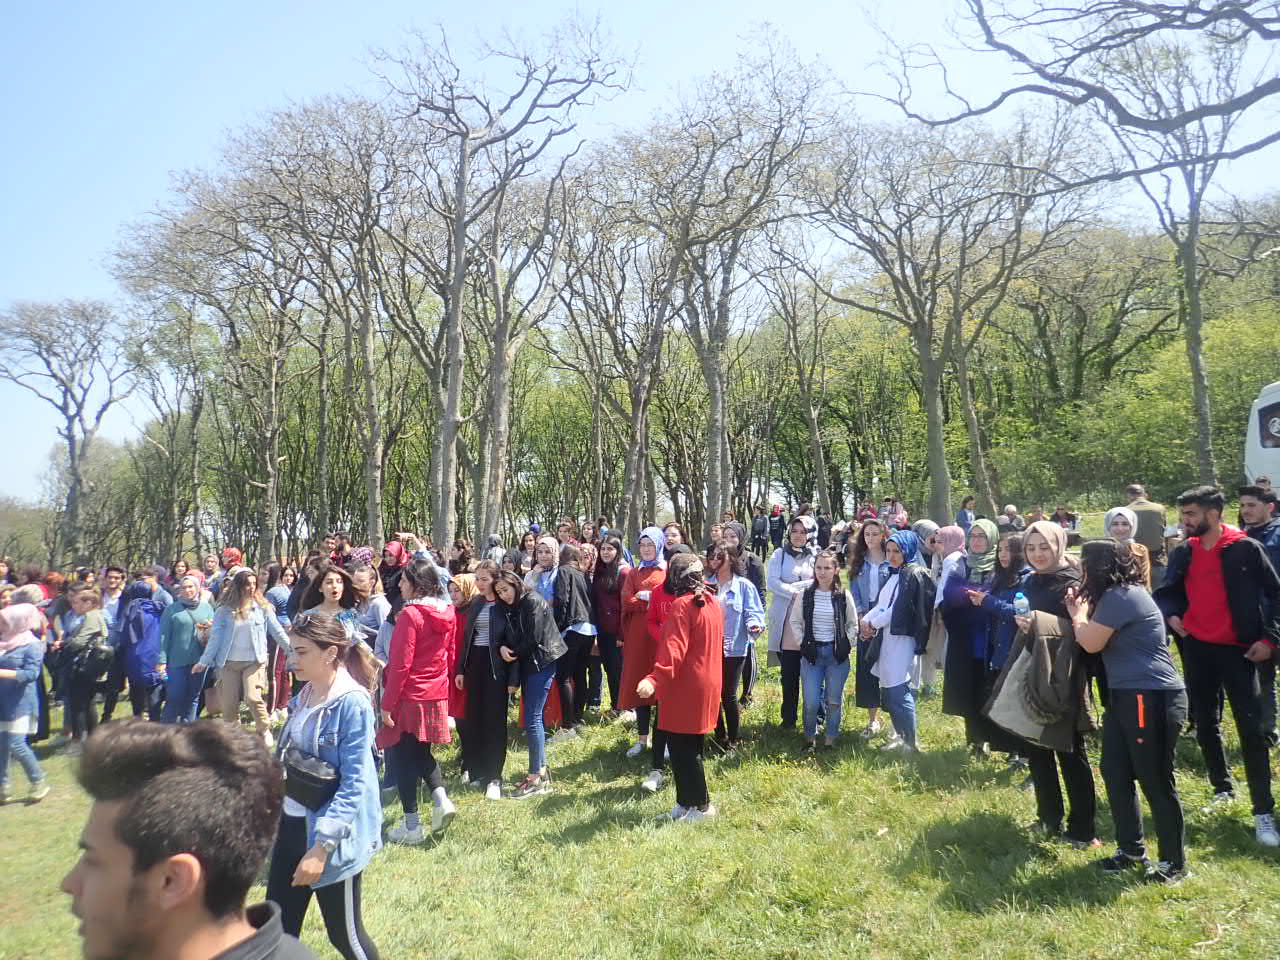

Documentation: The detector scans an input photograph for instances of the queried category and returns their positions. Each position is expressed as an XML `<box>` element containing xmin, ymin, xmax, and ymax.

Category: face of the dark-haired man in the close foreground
<box><xmin>61</xmin><ymin>801</ymin><xmax>157</xmax><ymax>960</ymax></box>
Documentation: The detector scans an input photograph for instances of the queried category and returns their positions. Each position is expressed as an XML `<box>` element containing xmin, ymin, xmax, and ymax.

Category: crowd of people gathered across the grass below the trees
<box><xmin>0</xmin><ymin>480</ymin><xmax>1280</xmax><ymax>957</ymax></box>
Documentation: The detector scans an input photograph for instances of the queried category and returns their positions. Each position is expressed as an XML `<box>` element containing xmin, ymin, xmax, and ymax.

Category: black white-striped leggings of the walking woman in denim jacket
<box><xmin>266</xmin><ymin>817</ymin><xmax>379</xmax><ymax>960</ymax></box>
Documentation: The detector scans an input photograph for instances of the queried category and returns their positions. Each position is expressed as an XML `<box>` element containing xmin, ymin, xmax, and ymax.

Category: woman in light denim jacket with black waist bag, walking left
<box><xmin>266</xmin><ymin>613</ymin><xmax>383</xmax><ymax>960</ymax></box>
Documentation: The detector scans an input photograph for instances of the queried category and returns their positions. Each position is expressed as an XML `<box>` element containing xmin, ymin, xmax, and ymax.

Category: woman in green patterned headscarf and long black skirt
<box><xmin>941</xmin><ymin>520</ymin><xmax>1000</xmax><ymax>756</ymax></box>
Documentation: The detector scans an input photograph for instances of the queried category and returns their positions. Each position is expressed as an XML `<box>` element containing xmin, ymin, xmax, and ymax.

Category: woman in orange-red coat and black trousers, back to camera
<box><xmin>636</xmin><ymin>553</ymin><xmax>724</xmax><ymax>822</ymax></box>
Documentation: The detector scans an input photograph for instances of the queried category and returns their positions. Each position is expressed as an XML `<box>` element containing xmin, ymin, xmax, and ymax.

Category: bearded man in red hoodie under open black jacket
<box><xmin>1156</xmin><ymin>486</ymin><xmax>1280</xmax><ymax>847</ymax></box>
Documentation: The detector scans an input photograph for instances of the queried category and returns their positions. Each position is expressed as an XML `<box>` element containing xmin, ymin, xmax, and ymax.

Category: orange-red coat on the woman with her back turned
<box><xmin>649</xmin><ymin>593</ymin><xmax>724</xmax><ymax>733</ymax></box>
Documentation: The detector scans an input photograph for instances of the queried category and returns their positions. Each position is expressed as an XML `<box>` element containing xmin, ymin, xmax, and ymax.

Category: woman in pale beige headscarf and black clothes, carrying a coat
<box><xmin>1018</xmin><ymin>520</ymin><xmax>1101</xmax><ymax>847</ymax></box>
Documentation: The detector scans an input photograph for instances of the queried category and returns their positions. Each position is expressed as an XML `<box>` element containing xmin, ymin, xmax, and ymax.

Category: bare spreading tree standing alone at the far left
<box><xmin>0</xmin><ymin>300</ymin><xmax>134</xmax><ymax>563</ymax></box>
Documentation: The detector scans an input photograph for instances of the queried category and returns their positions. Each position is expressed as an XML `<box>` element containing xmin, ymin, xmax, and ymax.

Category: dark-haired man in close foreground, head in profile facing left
<box><xmin>61</xmin><ymin>721</ymin><xmax>315</xmax><ymax>960</ymax></box>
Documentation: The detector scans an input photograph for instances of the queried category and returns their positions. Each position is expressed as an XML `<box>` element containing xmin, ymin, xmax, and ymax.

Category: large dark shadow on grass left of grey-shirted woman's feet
<box><xmin>897</xmin><ymin>813</ymin><xmax>1129</xmax><ymax>915</ymax></box>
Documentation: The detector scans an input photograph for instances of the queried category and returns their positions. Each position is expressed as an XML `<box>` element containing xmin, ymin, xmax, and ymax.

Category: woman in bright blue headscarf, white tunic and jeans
<box><xmin>861</xmin><ymin>530</ymin><xmax>933</xmax><ymax>753</ymax></box>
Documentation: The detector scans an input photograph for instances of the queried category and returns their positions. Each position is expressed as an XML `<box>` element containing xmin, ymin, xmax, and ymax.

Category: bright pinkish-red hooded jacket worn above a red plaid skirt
<box><xmin>383</xmin><ymin>600</ymin><xmax>457</xmax><ymax>717</ymax></box>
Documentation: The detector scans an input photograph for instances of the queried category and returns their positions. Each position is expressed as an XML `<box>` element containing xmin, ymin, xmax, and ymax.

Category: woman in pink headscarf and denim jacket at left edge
<box><xmin>0</xmin><ymin>586</ymin><xmax>49</xmax><ymax>803</ymax></box>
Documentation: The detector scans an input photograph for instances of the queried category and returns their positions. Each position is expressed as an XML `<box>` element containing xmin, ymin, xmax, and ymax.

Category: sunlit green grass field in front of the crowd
<box><xmin>0</xmin><ymin>672</ymin><xmax>1280</xmax><ymax>960</ymax></box>
